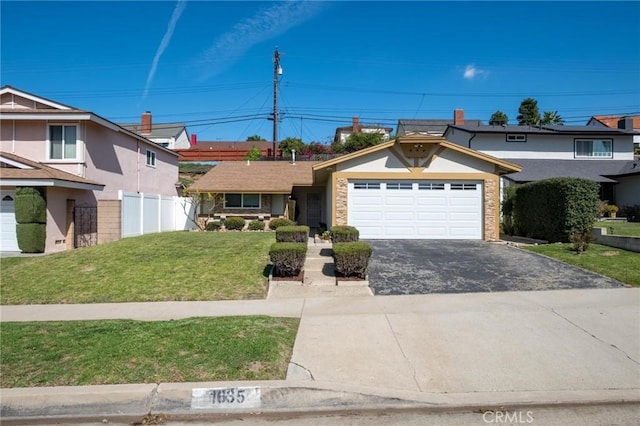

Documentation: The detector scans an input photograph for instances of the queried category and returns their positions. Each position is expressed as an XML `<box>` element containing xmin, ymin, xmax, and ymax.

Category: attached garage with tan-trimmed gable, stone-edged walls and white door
<box><xmin>313</xmin><ymin>134</ymin><xmax>522</xmax><ymax>240</ymax></box>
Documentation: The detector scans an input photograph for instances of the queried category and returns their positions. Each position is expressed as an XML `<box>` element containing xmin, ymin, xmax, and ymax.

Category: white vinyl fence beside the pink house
<box><xmin>118</xmin><ymin>191</ymin><xmax>195</xmax><ymax>238</ymax></box>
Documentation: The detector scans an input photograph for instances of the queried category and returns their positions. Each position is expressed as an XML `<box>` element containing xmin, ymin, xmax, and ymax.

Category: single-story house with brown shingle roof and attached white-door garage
<box><xmin>189</xmin><ymin>135</ymin><xmax>521</xmax><ymax>240</ymax></box>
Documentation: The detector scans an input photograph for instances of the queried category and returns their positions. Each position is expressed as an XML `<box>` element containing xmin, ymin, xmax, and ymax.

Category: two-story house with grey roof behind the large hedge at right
<box><xmin>444</xmin><ymin>123</ymin><xmax>640</xmax><ymax>205</ymax></box>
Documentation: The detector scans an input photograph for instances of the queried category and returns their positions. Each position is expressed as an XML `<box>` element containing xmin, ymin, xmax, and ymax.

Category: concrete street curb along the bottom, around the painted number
<box><xmin>0</xmin><ymin>381</ymin><xmax>640</xmax><ymax>425</ymax></box>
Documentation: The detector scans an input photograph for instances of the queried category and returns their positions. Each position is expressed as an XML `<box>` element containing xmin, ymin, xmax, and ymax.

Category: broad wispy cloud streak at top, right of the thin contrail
<box><xmin>196</xmin><ymin>1</ymin><xmax>324</xmax><ymax>80</ymax></box>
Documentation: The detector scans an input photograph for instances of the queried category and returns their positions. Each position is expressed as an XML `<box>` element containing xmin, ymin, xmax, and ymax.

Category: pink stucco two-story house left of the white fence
<box><xmin>0</xmin><ymin>86</ymin><xmax>178</xmax><ymax>252</ymax></box>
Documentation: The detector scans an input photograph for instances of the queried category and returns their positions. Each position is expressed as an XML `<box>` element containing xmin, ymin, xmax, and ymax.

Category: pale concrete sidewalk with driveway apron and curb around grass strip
<box><xmin>1</xmin><ymin>288</ymin><xmax>640</xmax><ymax>423</ymax></box>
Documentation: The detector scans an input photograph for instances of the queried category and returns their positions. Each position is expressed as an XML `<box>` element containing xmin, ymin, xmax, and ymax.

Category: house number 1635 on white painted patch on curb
<box><xmin>191</xmin><ymin>386</ymin><xmax>262</xmax><ymax>409</ymax></box>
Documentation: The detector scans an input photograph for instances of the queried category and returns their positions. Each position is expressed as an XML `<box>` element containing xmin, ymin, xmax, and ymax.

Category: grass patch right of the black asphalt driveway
<box><xmin>523</xmin><ymin>243</ymin><xmax>640</xmax><ymax>286</ymax></box>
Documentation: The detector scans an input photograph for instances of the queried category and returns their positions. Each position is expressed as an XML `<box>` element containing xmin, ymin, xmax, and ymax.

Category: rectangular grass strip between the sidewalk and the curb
<box><xmin>0</xmin><ymin>316</ymin><xmax>299</xmax><ymax>388</ymax></box>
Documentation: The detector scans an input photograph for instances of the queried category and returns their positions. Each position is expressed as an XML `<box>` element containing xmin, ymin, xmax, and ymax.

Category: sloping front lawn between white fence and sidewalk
<box><xmin>0</xmin><ymin>232</ymin><xmax>275</xmax><ymax>305</ymax></box>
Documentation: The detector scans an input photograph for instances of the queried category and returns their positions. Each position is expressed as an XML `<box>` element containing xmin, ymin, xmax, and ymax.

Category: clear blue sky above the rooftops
<box><xmin>0</xmin><ymin>0</ymin><xmax>640</xmax><ymax>142</ymax></box>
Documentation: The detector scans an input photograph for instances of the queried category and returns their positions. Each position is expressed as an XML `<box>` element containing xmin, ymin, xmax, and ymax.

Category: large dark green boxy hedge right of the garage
<box><xmin>513</xmin><ymin>178</ymin><xmax>600</xmax><ymax>242</ymax></box>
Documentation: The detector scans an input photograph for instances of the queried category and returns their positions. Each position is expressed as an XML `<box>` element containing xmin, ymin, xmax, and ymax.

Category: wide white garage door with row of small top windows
<box><xmin>348</xmin><ymin>181</ymin><xmax>483</xmax><ymax>239</ymax></box>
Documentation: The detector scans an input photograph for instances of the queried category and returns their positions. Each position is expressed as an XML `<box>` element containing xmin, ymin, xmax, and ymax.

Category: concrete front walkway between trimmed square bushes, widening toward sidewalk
<box><xmin>267</xmin><ymin>239</ymin><xmax>373</xmax><ymax>299</ymax></box>
